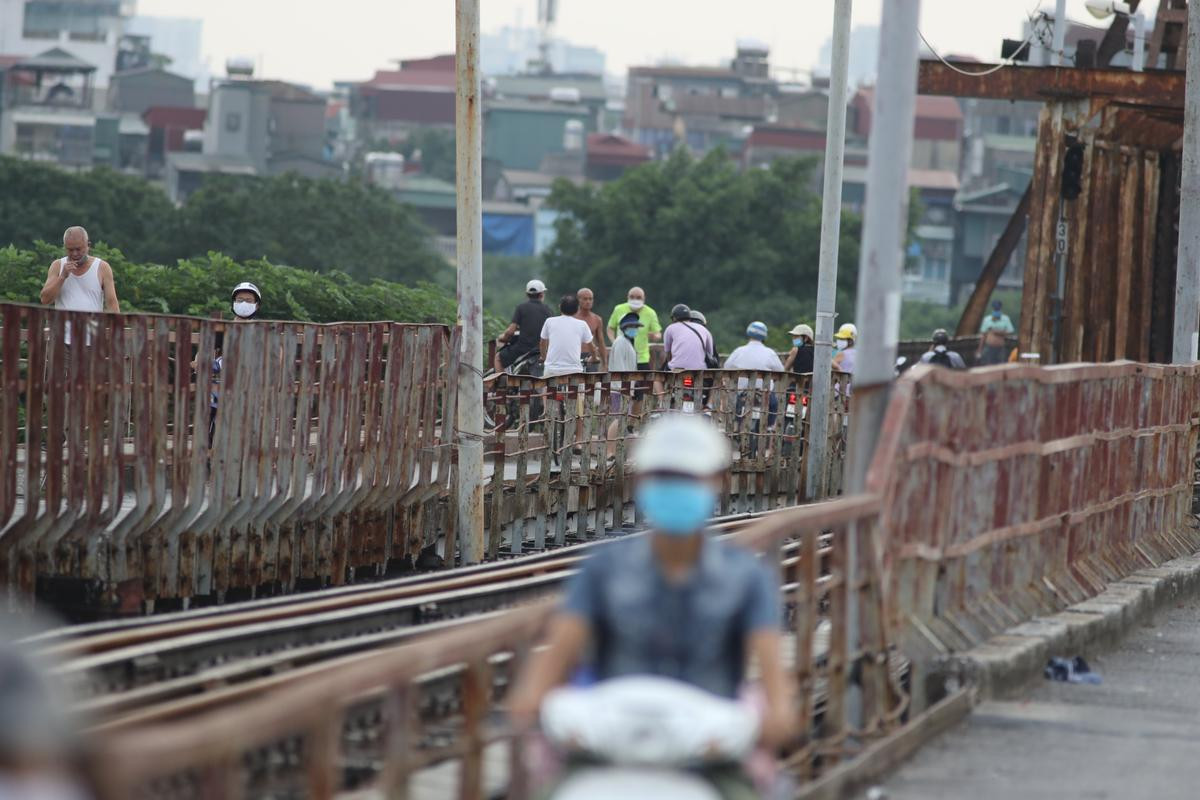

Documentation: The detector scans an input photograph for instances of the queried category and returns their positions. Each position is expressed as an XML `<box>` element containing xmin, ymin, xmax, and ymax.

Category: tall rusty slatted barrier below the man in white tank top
<box><xmin>0</xmin><ymin>305</ymin><xmax>458</xmax><ymax>610</ymax></box>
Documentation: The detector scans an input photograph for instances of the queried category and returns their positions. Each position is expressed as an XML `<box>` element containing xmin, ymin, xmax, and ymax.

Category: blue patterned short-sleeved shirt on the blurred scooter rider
<box><xmin>563</xmin><ymin>536</ymin><xmax>781</xmax><ymax>697</ymax></box>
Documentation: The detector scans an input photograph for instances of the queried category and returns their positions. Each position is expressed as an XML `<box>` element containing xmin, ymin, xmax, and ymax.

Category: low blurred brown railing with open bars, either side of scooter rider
<box><xmin>94</xmin><ymin>498</ymin><xmax>906</xmax><ymax>800</ymax></box>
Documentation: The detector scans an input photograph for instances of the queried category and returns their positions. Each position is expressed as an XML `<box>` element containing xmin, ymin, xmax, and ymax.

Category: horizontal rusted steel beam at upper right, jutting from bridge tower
<box><xmin>917</xmin><ymin>61</ymin><xmax>1183</xmax><ymax>108</ymax></box>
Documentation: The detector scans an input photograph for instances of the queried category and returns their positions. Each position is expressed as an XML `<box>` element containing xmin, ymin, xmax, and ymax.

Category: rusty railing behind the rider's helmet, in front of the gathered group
<box><xmin>485</xmin><ymin>369</ymin><xmax>850</xmax><ymax>557</ymax></box>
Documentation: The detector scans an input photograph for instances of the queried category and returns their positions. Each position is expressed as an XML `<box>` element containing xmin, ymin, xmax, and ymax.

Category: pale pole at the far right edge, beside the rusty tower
<box><xmin>1171</xmin><ymin>0</ymin><xmax>1200</xmax><ymax>363</ymax></box>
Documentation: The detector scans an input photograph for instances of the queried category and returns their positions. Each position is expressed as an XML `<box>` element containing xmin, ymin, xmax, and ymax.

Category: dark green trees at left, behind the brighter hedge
<box><xmin>0</xmin><ymin>157</ymin><xmax>446</xmax><ymax>283</ymax></box>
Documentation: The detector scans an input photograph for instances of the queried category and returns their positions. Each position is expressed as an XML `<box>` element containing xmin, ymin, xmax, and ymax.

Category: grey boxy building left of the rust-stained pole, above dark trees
<box><xmin>167</xmin><ymin>78</ymin><xmax>342</xmax><ymax>201</ymax></box>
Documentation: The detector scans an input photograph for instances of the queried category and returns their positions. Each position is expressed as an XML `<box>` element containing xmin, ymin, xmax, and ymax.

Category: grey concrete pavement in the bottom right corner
<box><xmin>882</xmin><ymin>597</ymin><xmax>1200</xmax><ymax>800</ymax></box>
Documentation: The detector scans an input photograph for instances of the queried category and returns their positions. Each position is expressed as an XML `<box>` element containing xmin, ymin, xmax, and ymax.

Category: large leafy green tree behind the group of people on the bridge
<box><xmin>545</xmin><ymin>150</ymin><xmax>862</xmax><ymax>353</ymax></box>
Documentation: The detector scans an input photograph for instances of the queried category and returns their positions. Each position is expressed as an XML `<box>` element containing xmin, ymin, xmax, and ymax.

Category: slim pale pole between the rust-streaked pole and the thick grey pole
<box><xmin>806</xmin><ymin>0</ymin><xmax>853</xmax><ymax>500</ymax></box>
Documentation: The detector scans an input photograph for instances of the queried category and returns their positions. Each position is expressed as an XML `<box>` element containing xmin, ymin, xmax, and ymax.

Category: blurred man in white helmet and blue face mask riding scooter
<box><xmin>509</xmin><ymin>414</ymin><xmax>796</xmax><ymax>796</ymax></box>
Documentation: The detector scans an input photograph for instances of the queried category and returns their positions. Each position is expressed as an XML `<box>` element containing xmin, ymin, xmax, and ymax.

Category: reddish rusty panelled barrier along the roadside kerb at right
<box><xmin>870</xmin><ymin>362</ymin><xmax>1200</xmax><ymax>656</ymax></box>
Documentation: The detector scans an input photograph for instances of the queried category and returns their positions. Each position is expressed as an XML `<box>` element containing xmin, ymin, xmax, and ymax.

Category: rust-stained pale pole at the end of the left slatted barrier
<box><xmin>443</xmin><ymin>0</ymin><xmax>484</xmax><ymax>564</ymax></box>
